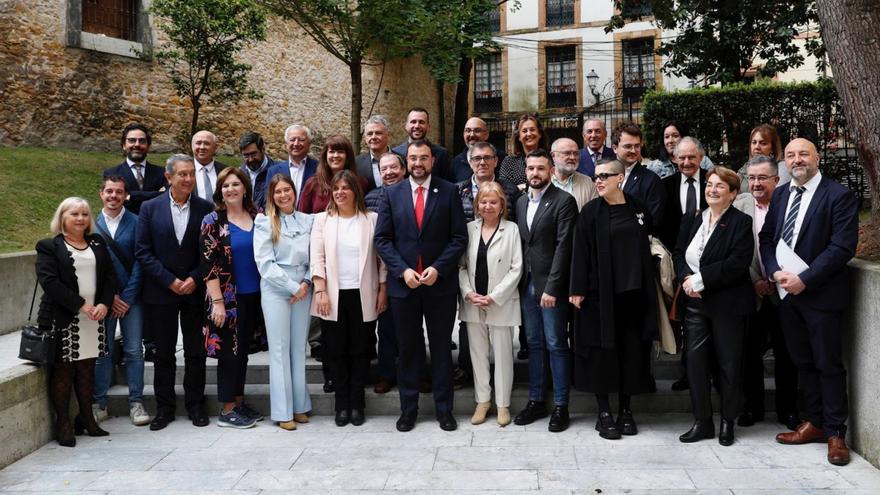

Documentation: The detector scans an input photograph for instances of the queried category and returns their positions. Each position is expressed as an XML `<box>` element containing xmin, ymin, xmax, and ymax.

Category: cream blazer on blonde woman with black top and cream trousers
<box><xmin>458</xmin><ymin>219</ymin><xmax>522</xmax><ymax>327</ymax></box>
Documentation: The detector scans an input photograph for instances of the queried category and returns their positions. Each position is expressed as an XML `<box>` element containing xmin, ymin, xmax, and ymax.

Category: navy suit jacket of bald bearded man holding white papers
<box><xmin>758</xmin><ymin>176</ymin><xmax>859</xmax><ymax>311</ymax></box>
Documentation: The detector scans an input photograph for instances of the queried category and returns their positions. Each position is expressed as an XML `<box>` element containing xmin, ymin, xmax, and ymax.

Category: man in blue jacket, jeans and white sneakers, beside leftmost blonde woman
<box><xmin>92</xmin><ymin>175</ymin><xmax>151</xmax><ymax>426</ymax></box>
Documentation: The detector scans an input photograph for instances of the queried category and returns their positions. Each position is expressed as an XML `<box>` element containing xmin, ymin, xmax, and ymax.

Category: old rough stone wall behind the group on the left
<box><xmin>0</xmin><ymin>0</ymin><xmax>454</xmax><ymax>157</ymax></box>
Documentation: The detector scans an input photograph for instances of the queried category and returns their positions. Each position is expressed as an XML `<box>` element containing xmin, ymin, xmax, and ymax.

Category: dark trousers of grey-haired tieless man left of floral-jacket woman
<box><xmin>150</xmin><ymin>302</ymin><xmax>205</xmax><ymax>415</ymax></box>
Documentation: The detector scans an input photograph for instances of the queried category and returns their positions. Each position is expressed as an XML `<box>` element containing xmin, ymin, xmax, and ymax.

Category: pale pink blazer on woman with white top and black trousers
<box><xmin>310</xmin><ymin>211</ymin><xmax>388</xmax><ymax>321</ymax></box>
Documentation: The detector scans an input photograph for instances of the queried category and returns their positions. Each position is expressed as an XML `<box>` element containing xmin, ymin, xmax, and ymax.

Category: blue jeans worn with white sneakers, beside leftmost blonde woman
<box><xmin>95</xmin><ymin>302</ymin><xmax>144</xmax><ymax>409</ymax></box>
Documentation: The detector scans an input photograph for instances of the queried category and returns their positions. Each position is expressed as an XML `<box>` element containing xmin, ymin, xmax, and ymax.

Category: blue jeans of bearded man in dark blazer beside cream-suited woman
<box><xmin>520</xmin><ymin>277</ymin><xmax>571</xmax><ymax>406</ymax></box>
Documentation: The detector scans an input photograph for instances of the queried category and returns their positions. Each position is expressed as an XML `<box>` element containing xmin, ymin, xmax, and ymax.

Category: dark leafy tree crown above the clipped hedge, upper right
<box><xmin>606</xmin><ymin>0</ymin><xmax>824</xmax><ymax>84</ymax></box>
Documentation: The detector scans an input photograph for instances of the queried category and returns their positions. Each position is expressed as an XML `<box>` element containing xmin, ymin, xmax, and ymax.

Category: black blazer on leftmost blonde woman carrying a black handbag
<box><xmin>36</xmin><ymin>234</ymin><xmax>117</xmax><ymax>328</ymax></box>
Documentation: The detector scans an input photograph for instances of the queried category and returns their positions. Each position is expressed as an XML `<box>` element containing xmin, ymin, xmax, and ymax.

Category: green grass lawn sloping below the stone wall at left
<box><xmin>0</xmin><ymin>147</ymin><xmax>241</xmax><ymax>253</ymax></box>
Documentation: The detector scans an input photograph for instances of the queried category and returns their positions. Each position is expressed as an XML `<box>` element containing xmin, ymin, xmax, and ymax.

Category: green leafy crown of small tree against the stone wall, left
<box><xmin>150</xmin><ymin>0</ymin><xmax>266</xmax><ymax>134</ymax></box>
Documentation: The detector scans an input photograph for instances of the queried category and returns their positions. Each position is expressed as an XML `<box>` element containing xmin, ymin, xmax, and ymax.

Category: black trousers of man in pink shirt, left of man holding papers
<box><xmin>743</xmin><ymin>298</ymin><xmax>798</xmax><ymax>417</ymax></box>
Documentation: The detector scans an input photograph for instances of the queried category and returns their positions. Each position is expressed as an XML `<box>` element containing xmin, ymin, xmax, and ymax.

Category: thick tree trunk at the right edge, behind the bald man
<box><xmin>816</xmin><ymin>0</ymin><xmax>880</xmax><ymax>219</ymax></box>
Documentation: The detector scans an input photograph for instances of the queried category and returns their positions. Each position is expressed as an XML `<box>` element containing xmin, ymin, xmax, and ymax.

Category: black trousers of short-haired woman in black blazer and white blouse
<box><xmin>684</xmin><ymin>298</ymin><xmax>746</xmax><ymax>421</ymax></box>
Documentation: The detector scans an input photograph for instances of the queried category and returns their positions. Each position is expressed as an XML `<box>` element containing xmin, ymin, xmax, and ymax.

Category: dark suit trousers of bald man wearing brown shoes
<box><xmin>779</xmin><ymin>299</ymin><xmax>849</xmax><ymax>436</ymax></box>
